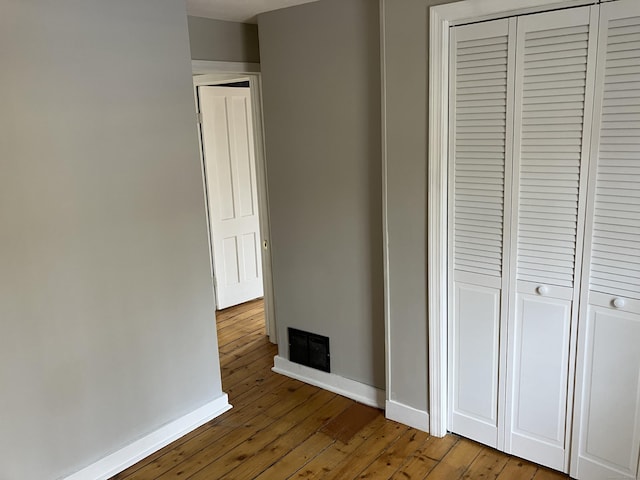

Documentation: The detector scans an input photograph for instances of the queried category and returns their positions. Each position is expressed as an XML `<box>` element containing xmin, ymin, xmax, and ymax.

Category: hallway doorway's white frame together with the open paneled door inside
<box><xmin>194</xmin><ymin>73</ymin><xmax>277</xmax><ymax>343</ymax></box>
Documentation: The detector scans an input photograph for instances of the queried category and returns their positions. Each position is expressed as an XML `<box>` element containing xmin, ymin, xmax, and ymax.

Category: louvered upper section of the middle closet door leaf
<box><xmin>516</xmin><ymin>25</ymin><xmax>589</xmax><ymax>287</ymax></box>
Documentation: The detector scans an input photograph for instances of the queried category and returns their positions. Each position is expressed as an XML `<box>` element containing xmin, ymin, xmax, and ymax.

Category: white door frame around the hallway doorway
<box><xmin>192</xmin><ymin>60</ymin><xmax>278</xmax><ymax>344</ymax></box>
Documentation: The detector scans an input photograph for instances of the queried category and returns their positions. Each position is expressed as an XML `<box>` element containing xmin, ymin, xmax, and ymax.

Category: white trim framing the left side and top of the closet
<box><xmin>430</xmin><ymin>0</ymin><xmax>599</xmax><ymax>437</ymax></box>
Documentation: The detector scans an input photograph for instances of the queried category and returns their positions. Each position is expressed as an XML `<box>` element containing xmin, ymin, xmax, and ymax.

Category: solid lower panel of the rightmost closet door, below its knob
<box><xmin>572</xmin><ymin>306</ymin><xmax>640</xmax><ymax>480</ymax></box>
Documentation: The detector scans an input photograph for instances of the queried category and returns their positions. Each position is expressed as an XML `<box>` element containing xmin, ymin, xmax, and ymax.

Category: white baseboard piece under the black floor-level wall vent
<box><xmin>272</xmin><ymin>356</ymin><xmax>385</xmax><ymax>409</ymax></box>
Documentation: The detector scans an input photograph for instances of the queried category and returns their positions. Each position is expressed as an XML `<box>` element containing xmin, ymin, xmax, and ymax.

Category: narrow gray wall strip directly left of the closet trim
<box><xmin>382</xmin><ymin>0</ymin><xmax>458</xmax><ymax>410</ymax></box>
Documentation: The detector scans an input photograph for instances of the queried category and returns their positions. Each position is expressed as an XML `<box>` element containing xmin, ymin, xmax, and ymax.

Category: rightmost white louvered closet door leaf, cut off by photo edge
<box><xmin>571</xmin><ymin>0</ymin><xmax>640</xmax><ymax>480</ymax></box>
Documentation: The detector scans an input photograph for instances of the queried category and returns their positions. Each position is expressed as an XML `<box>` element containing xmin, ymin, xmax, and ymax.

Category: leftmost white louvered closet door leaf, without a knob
<box><xmin>449</xmin><ymin>19</ymin><xmax>515</xmax><ymax>448</ymax></box>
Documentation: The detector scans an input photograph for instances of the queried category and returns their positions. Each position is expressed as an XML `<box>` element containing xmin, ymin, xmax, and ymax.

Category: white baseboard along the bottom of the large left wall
<box><xmin>64</xmin><ymin>393</ymin><xmax>231</xmax><ymax>480</ymax></box>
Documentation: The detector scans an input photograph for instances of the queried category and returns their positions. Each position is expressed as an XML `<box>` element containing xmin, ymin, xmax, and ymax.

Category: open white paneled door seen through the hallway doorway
<box><xmin>198</xmin><ymin>86</ymin><xmax>263</xmax><ymax>309</ymax></box>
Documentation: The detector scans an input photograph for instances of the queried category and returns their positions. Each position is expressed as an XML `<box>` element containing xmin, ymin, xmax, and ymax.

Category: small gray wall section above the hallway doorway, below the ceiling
<box><xmin>188</xmin><ymin>16</ymin><xmax>260</xmax><ymax>63</ymax></box>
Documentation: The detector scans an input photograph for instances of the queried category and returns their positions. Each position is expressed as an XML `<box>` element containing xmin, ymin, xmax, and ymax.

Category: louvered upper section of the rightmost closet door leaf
<box><xmin>590</xmin><ymin>17</ymin><xmax>640</xmax><ymax>300</ymax></box>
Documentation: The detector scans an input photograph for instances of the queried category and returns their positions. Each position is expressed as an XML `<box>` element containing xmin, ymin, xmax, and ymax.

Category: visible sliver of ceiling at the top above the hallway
<box><xmin>187</xmin><ymin>0</ymin><xmax>316</xmax><ymax>23</ymax></box>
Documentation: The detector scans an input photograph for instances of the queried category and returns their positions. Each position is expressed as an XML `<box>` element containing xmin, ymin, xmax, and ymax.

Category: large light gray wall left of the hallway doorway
<box><xmin>0</xmin><ymin>0</ymin><xmax>221</xmax><ymax>480</ymax></box>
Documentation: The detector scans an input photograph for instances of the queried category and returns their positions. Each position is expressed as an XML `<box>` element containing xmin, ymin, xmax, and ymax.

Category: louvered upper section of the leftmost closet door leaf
<box><xmin>453</xmin><ymin>30</ymin><xmax>508</xmax><ymax>277</ymax></box>
